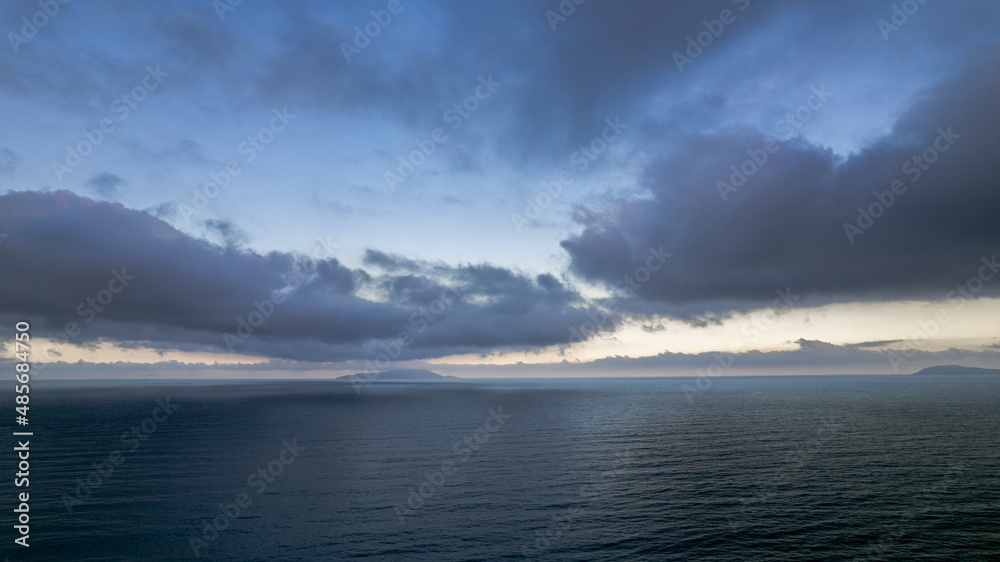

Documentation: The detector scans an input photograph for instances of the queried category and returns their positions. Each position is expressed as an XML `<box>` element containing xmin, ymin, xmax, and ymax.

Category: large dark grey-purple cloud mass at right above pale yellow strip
<box><xmin>562</xmin><ymin>50</ymin><xmax>1000</xmax><ymax>311</ymax></box>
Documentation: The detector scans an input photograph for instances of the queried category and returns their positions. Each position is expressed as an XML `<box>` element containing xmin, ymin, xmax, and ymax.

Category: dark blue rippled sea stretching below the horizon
<box><xmin>0</xmin><ymin>376</ymin><xmax>1000</xmax><ymax>560</ymax></box>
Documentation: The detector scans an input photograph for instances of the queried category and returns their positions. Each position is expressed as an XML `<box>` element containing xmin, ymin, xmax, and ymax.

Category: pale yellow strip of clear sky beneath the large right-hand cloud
<box><xmin>426</xmin><ymin>299</ymin><xmax>1000</xmax><ymax>365</ymax></box>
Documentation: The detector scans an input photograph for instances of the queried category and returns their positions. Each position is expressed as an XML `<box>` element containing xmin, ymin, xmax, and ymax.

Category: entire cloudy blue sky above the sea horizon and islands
<box><xmin>0</xmin><ymin>0</ymin><xmax>1000</xmax><ymax>378</ymax></box>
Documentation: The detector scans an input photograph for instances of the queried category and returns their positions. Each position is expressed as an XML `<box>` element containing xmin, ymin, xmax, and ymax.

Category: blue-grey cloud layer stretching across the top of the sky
<box><xmin>0</xmin><ymin>0</ymin><xmax>997</xmax><ymax>163</ymax></box>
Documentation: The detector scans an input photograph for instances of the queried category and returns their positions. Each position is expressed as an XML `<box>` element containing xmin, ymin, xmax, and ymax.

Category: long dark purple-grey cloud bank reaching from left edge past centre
<box><xmin>0</xmin><ymin>191</ymin><xmax>608</xmax><ymax>361</ymax></box>
